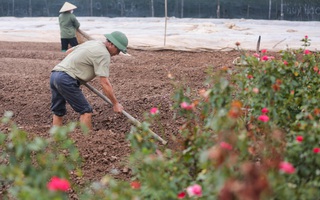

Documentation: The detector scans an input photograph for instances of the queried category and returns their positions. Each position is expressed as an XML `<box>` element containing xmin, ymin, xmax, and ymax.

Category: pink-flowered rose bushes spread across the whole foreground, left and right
<box><xmin>0</xmin><ymin>36</ymin><xmax>320</xmax><ymax>200</ymax></box>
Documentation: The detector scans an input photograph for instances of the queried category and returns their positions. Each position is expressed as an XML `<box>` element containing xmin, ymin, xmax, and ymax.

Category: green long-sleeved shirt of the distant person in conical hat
<box><xmin>59</xmin><ymin>12</ymin><xmax>80</xmax><ymax>39</ymax></box>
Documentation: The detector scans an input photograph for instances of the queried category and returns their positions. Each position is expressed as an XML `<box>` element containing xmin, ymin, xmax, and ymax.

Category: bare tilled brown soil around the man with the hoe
<box><xmin>0</xmin><ymin>42</ymin><xmax>239</xmax><ymax>194</ymax></box>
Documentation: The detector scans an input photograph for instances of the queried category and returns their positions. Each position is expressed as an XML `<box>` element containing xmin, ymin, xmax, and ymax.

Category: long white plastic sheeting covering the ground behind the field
<box><xmin>0</xmin><ymin>17</ymin><xmax>320</xmax><ymax>51</ymax></box>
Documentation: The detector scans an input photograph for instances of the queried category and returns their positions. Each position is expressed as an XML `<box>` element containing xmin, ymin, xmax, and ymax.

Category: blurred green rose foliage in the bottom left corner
<box><xmin>0</xmin><ymin>113</ymin><xmax>80</xmax><ymax>199</ymax></box>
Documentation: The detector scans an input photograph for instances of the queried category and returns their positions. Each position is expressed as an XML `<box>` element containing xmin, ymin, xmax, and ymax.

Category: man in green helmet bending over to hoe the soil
<box><xmin>50</xmin><ymin>31</ymin><xmax>128</xmax><ymax>130</ymax></box>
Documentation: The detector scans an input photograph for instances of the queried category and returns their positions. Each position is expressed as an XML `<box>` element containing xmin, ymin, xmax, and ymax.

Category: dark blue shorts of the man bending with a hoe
<box><xmin>50</xmin><ymin>71</ymin><xmax>92</xmax><ymax>116</ymax></box>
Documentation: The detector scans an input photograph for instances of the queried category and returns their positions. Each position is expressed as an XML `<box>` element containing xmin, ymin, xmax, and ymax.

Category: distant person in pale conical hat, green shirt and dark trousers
<box><xmin>59</xmin><ymin>2</ymin><xmax>80</xmax><ymax>52</ymax></box>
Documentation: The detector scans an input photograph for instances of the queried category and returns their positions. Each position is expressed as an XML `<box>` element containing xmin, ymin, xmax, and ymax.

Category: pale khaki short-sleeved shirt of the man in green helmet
<box><xmin>52</xmin><ymin>40</ymin><xmax>111</xmax><ymax>82</ymax></box>
